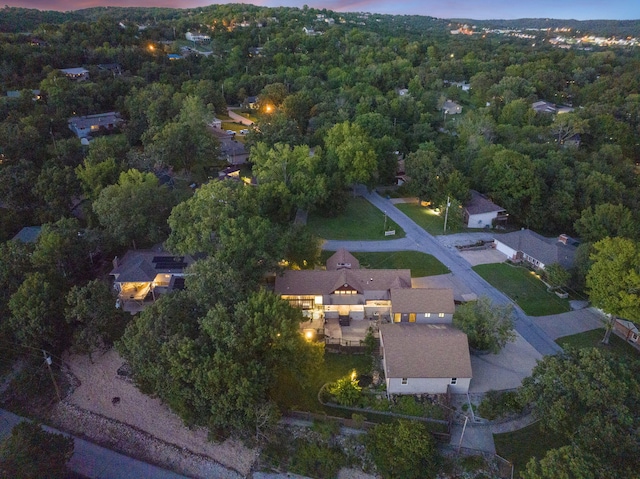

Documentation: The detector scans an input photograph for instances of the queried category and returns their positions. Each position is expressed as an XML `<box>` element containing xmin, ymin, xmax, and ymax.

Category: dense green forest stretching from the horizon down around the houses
<box><xmin>0</xmin><ymin>4</ymin><xmax>640</xmax><ymax>477</ymax></box>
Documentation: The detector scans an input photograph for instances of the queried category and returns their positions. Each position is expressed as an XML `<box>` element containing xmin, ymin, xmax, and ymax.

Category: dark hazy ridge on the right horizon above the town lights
<box><xmin>451</xmin><ymin>18</ymin><xmax>640</xmax><ymax>37</ymax></box>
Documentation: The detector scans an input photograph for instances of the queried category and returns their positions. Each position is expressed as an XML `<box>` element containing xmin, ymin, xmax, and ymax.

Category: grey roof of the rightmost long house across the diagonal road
<box><xmin>496</xmin><ymin>229</ymin><xmax>576</xmax><ymax>268</ymax></box>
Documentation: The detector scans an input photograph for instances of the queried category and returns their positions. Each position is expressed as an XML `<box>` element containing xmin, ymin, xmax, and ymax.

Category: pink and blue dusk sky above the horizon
<box><xmin>2</xmin><ymin>0</ymin><xmax>640</xmax><ymax>20</ymax></box>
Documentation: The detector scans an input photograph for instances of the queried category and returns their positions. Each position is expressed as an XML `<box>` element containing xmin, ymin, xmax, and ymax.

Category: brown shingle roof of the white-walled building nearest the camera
<box><xmin>380</xmin><ymin>323</ymin><xmax>472</xmax><ymax>378</ymax></box>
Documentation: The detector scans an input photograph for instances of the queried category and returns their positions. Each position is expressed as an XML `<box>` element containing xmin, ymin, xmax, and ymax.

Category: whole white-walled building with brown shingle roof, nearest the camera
<box><xmin>380</xmin><ymin>324</ymin><xmax>472</xmax><ymax>394</ymax></box>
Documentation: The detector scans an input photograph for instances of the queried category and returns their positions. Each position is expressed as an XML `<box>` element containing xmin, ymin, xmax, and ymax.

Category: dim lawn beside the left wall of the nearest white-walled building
<box><xmin>272</xmin><ymin>353</ymin><xmax>371</xmax><ymax>417</ymax></box>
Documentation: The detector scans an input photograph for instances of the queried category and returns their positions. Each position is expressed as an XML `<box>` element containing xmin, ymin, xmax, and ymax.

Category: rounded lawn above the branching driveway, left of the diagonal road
<box><xmin>307</xmin><ymin>198</ymin><xmax>405</xmax><ymax>241</ymax></box>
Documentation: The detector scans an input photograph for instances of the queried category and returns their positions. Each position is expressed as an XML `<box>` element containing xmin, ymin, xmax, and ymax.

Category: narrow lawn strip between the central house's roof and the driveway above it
<box><xmin>321</xmin><ymin>251</ymin><xmax>449</xmax><ymax>278</ymax></box>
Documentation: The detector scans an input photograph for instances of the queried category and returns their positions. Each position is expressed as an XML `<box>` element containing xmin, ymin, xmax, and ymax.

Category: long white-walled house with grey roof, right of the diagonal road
<box><xmin>494</xmin><ymin>229</ymin><xmax>577</xmax><ymax>269</ymax></box>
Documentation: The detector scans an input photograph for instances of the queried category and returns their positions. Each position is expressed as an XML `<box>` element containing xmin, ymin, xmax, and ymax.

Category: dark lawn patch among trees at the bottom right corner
<box><xmin>493</xmin><ymin>423</ymin><xmax>566</xmax><ymax>477</ymax></box>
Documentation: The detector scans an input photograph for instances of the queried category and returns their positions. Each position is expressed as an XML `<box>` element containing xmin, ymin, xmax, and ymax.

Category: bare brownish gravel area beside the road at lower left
<box><xmin>52</xmin><ymin>350</ymin><xmax>258</xmax><ymax>479</ymax></box>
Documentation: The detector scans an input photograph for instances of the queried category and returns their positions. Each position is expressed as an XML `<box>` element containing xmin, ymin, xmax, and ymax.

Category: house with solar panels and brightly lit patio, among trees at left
<box><xmin>109</xmin><ymin>248</ymin><xmax>193</xmax><ymax>314</ymax></box>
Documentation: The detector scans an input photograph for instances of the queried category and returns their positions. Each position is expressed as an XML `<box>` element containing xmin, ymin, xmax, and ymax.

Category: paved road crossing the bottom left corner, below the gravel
<box><xmin>0</xmin><ymin>409</ymin><xmax>187</xmax><ymax>479</ymax></box>
